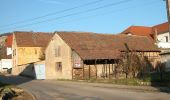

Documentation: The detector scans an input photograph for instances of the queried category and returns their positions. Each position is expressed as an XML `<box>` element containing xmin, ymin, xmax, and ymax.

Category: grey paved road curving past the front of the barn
<box><xmin>0</xmin><ymin>76</ymin><xmax>170</xmax><ymax>100</ymax></box>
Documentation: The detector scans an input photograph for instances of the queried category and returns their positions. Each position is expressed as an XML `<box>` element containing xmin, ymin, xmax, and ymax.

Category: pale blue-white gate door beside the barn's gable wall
<box><xmin>35</xmin><ymin>64</ymin><xmax>45</xmax><ymax>79</ymax></box>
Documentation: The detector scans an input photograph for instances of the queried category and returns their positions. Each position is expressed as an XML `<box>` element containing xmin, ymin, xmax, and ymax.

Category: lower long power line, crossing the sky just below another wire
<box><xmin>0</xmin><ymin>0</ymin><xmax>133</xmax><ymax>30</ymax></box>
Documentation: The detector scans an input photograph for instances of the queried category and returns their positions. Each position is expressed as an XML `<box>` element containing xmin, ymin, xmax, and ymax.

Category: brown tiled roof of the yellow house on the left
<box><xmin>14</xmin><ymin>31</ymin><xmax>53</xmax><ymax>47</ymax></box>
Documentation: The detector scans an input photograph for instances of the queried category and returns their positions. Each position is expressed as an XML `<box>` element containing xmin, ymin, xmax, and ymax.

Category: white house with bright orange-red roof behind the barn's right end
<box><xmin>120</xmin><ymin>22</ymin><xmax>170</xmax><ymax>49</ymax></box>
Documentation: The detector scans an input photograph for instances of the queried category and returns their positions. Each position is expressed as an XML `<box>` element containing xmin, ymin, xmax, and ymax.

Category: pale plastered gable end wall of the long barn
<box><xmin>45</xmin><ymin>34</ymin><xmax>72</xmax><ymax>79</ymax></box>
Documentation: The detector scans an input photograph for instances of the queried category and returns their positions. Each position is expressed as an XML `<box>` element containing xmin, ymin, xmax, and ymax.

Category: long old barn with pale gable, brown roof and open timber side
<box><xmin>45</xmin><ymin>32</ymin><xmax>160</xmax><ymax>79</ymax></box>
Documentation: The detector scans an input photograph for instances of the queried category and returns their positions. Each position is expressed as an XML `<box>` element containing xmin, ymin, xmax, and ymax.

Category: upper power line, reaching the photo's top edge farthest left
<box><xmin>0</xmin><ymin>0</ymin><xmax>103</xmax><ymax>27</ymax></box>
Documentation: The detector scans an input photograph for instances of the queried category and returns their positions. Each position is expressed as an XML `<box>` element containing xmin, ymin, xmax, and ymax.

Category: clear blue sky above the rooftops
<box><xmin>0</xmin><ymin>0</ymin><xmax>167</xmax><ymax>34</ymax></box>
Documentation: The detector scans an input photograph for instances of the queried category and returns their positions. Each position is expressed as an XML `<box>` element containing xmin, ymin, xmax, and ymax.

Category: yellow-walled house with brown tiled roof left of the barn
<box><xmin>12</xmin><ymin>31</ymin><xmax>52</xmax><ymax>77</ymax></box>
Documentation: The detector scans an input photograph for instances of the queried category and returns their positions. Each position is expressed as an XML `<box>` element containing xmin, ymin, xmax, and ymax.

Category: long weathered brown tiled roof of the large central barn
<box><xmin>57</xmin><ymin>32</ymin><xmax>159</xmax><ymax>59</ymax></box>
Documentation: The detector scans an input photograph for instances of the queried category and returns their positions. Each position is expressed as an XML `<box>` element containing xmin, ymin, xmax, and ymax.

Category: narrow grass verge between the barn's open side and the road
<box><xmin>57</xmin><ymin>72</ymin><xmax>170</xmax><ymax>86</ymax></box>
